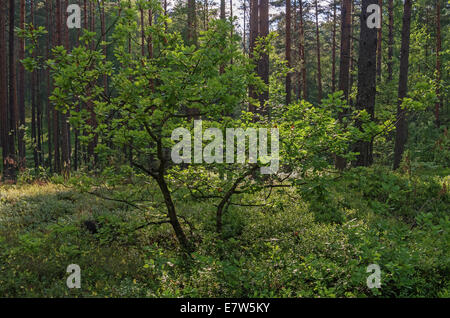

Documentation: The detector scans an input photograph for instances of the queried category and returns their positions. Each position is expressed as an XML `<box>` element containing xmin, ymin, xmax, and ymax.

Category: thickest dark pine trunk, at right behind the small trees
<box><xmin>355</xmin><ymin>0</ymin><xmax>378</xmax><ymax>167</ymax></box>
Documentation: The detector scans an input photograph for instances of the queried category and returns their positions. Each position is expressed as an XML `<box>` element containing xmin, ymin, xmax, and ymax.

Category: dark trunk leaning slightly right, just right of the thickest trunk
<box><xmin>394</xmin><ymin>0</ymin><xmax>412</xmax><ymax>170</ymax></box>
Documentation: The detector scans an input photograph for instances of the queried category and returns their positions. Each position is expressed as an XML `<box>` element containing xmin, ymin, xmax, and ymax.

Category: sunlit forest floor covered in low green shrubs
<box><xmin>0</xmin><ymin>167</ymin><xmax>450</xmax><ymax>297</ymax></box>
